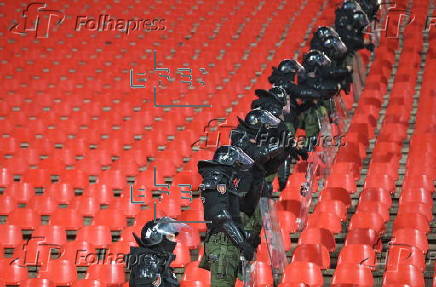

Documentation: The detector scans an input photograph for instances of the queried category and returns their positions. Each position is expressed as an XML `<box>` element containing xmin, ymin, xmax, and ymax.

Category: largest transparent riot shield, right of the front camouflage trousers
<box><xmin>259</xmin><ymin>197</ymin><xmax>288</xmax><ymax>281</ymax></box>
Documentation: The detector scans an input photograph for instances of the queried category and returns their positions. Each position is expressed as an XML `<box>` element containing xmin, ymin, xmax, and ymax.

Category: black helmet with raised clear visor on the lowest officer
<box><xmin>133</xmin><ymin>217</ymin><xmax>188</xmax><ymax>247</ymax></box>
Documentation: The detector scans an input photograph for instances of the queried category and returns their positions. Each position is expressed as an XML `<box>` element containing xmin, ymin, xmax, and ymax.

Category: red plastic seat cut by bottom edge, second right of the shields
<box><xmin>332</xmin><ymin>264</ymin><xmax>374</xmax><ymax>287</ymax></box>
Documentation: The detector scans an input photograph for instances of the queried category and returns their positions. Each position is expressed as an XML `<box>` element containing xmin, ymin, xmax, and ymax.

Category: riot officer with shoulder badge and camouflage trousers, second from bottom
<box><xmin>198</xmin><ymin>146</ymin><xmax>258</xmax><ymax>287</ymax></box>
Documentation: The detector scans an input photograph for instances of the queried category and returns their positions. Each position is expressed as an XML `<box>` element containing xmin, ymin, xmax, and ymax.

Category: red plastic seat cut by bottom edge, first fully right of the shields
<box><xmin>282</xmin><ymin>262</ymin><xmax>324</xmax><ymax>287</ymax></box>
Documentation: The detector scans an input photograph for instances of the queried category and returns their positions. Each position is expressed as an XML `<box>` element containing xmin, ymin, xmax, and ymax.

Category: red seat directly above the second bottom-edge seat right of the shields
<box><xmin>337</xmin><ymin>244</ymin><xmax>376</xmax><ymax>268</ymax></box>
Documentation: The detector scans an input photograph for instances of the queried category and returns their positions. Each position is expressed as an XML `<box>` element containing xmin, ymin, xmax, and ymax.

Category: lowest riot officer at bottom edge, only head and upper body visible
<box><xmin>127</xmin><ymin>217</ymin><xmax>187</xmax><ymax>287</ymax></box>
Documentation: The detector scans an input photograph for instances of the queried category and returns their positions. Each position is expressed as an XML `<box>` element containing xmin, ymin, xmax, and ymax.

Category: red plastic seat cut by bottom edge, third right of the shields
<box><xmin>383</xmin><ymin>264</ymin><xmax>425</xmax><ymax>287</ymax></box>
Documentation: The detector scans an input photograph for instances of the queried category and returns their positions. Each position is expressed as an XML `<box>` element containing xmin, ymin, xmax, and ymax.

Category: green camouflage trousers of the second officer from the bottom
<box><xmin>199</xmin><ymin>232</ymin><xmax>240</xmax><ymax>287</ymax></box>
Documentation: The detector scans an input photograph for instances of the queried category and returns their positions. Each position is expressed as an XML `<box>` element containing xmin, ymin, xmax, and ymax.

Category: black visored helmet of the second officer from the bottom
<box><xmin>213</xmin><ymin>145</ymin><xmax>254</xmax><ymax>170</ymax></box>
